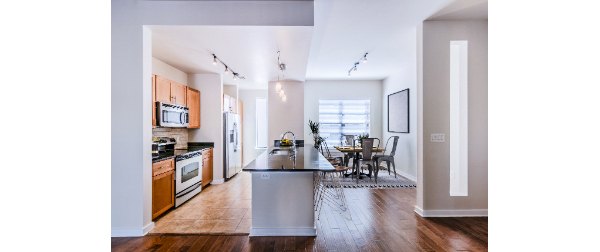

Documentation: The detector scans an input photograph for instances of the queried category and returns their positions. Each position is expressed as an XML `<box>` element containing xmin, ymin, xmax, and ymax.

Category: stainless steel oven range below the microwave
<box><xmin>175</xmin><ymin>151</ymin><xmax>202</xmax><ymax>207</ymax></box>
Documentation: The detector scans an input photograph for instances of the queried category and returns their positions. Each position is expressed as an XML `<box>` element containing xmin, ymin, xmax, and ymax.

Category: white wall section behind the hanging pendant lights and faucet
<box><xmin>267</xmin><ymin>81</ymin><xmax>304</xmax><ymax>146</ymax></box>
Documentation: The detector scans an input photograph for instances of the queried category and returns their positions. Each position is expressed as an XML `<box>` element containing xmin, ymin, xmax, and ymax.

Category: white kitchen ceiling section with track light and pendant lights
<box><xmin>151</xmin><ymin>26</ymin><xmax>313</xmax><ymax>89</ymax></box>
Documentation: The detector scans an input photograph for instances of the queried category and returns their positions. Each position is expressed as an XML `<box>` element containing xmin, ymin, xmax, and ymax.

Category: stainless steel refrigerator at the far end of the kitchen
<box><xmin>223</xmin><ymin>112</ymin><xmax>242</xmax><ymax>179</ymax></box>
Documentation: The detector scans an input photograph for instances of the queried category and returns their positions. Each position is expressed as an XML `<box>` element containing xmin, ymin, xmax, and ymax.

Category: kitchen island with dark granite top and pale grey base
<box><xmin>243</xmin><ymin>147</ymin><xmax>335</xmax><ymax>236</ymax></box>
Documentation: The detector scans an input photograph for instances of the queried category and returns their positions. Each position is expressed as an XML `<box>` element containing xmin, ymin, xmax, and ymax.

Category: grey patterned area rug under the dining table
<box><xmin>323</xmin><ymin>169</ymin><xmax>417</xmax><ymax>189</ymax></box>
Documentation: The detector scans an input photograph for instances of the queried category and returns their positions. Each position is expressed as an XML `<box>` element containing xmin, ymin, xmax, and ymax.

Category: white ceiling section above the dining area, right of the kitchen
<box><xmin>306</xmin><ymin>0</ymin><xmax>448</xmax><ymax>80</ymax></box>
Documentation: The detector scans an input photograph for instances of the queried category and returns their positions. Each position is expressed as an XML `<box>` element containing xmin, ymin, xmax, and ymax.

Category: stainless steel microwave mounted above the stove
<box><xmin>156</xmin><ymin>102</ymin><xmax>190</xmax><ymax>128</ymax></box>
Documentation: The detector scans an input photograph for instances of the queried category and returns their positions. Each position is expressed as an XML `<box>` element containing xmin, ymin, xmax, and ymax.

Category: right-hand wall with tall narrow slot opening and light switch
<box><xmin>417</xmin><ymin>21</ymin><xmax>488</xmax><ymax>215</ymax></box>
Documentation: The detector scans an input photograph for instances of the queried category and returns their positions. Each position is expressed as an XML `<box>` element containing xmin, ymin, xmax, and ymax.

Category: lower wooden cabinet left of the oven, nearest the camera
<box><xmin>152</xmin><ymin>158</ymin><xmax>175</xmax><ymax>219</ymax></box>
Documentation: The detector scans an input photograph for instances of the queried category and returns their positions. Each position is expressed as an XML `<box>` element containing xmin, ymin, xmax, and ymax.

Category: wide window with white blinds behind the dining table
<box><xmin>319</xmin><ymin>100</ymin><xmax>371</xmax><ymax>147</ymax></box>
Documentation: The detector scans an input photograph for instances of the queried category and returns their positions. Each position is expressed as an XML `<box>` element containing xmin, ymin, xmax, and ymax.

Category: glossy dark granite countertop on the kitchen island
<box><xmin>242</xmin><ymin>147</ymin><xmax>335</xmax><ymax>172</ymax></box>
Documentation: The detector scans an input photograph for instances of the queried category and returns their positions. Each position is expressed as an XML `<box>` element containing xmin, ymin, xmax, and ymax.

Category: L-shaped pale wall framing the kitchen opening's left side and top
<box><xmin>111</xmin><ymin>0</ymin><xmax>314</xmax><ymax>236</ymax></box>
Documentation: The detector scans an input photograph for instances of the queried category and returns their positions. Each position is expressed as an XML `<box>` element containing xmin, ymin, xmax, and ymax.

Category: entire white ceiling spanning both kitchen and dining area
<box><xmin>151</xmin><ymin>0</ymin><xmax>464</xmax><ymax>89</ymax></box>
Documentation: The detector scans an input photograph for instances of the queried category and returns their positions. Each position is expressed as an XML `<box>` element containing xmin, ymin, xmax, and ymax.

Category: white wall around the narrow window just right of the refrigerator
<box><xmin>239</xmin><ymin>89</ymin><xmax>267</xmax><ymax>166</ymax></box>
